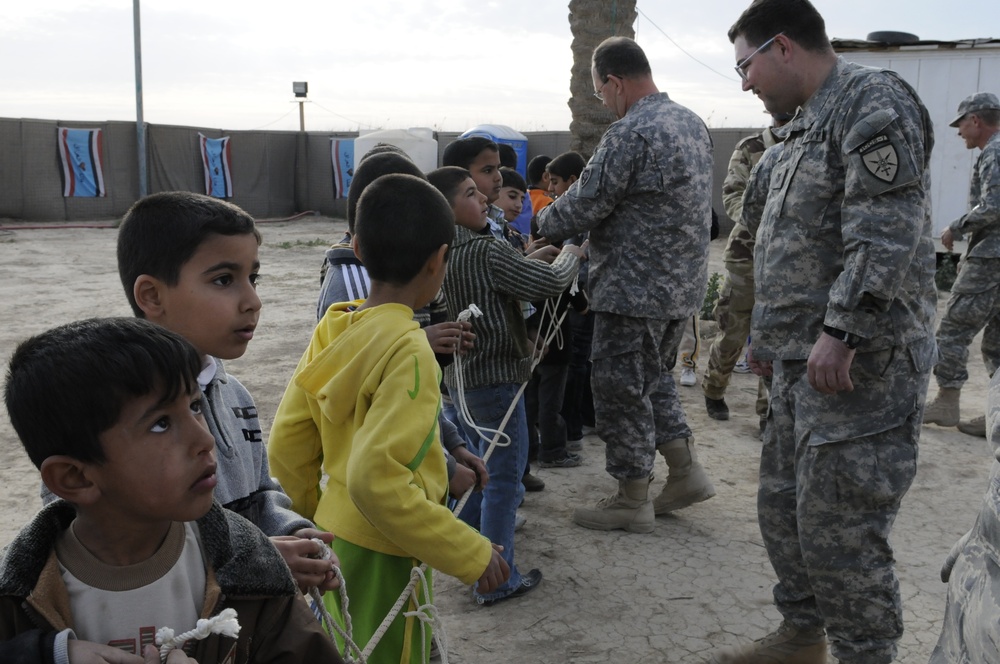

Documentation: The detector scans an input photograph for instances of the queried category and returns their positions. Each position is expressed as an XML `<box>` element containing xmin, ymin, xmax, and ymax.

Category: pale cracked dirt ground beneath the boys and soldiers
<box><xmin>0</xmin><ymin>217</ymin><xmax>992</xmax><ymax>664</ymax></box>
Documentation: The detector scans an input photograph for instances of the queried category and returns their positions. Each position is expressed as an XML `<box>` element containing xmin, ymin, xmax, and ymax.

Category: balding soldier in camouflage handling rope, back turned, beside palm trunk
<box><xmin>538</xmin><ymin>37</ymin><xmax>715</xmax><ymax>532</ymax></box>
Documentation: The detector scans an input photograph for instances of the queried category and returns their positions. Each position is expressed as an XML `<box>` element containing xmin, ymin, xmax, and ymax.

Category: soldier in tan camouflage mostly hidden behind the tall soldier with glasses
<box><xmin>701</xmin><ymin>113</ymin><xmax>792</xmax><ymax>429</ymax></box>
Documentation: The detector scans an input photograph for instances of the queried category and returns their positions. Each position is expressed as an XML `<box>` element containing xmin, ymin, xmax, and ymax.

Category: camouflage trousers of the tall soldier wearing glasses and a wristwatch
<box><xmin>757</xmin><ymin>339</ymin><xmax>934</xmax><ymax>664</ymax></box>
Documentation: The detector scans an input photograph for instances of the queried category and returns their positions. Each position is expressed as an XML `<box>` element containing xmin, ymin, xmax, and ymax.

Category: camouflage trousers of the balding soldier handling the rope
<box><xmin>590</xmin><ymin>311</ymin><xmax>691</xmax><ymax>480</ymax></box>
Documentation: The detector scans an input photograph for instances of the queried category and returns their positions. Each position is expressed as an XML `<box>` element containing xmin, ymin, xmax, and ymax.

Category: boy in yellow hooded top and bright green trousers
<box><xmin>269</xmin><ymin>175</ymin><xmax>510</xmax><ymax>664</ymax></box>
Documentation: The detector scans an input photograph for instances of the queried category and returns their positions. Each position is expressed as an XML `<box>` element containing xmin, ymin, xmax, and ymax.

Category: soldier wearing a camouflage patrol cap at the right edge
<box><xmin>924</xmin><ymin>92</ymin><xmax>1000</xmax><ymax>438</ymax></box>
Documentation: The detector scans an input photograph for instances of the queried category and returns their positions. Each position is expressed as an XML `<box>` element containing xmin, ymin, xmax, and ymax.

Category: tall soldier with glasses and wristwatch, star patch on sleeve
<box><xmin>714</xmin><ymin>0</ymin><xmax>936</xmax><ymax>664</ymax></box>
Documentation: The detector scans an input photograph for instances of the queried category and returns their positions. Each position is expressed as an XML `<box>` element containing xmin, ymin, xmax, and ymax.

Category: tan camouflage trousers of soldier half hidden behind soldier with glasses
<box><xmin>701</xmin><ymin>261</ymin><xmax>768</xmax><ymax>417</ymax></box>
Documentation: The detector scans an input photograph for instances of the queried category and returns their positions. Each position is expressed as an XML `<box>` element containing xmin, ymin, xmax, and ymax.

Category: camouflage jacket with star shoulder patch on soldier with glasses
<box><xmin>751</xmin><ymin>58</ymin><xmax>936</xmax><ymax>360</ymax></box>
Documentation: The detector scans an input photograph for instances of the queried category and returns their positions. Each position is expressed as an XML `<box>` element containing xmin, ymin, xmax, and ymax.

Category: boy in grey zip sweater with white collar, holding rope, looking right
<box><xmin>118</xmin><ymin>191</ymin><xmax>337</xmax><ymax>590</ymax></box>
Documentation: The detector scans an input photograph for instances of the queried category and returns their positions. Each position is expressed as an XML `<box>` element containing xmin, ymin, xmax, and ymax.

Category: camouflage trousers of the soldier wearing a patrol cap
<box><xmin>934</xmin><ymin>258</ymin><xmax>1000</xmax><ymax>388</ymax></box>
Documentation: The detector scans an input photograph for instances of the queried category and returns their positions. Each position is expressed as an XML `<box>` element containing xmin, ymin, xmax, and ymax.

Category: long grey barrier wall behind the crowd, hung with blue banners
<box><xmin>0</xmin><ymin>118</ymin><xmax>760</xmax><ymax>224</ymax></box>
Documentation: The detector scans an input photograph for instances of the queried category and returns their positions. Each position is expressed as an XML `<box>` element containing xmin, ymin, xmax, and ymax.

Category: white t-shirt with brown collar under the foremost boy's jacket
<box><xmin>56</xmin><ymin>522</ymin><xmax>205</xmax><ymax>655</ymax></box>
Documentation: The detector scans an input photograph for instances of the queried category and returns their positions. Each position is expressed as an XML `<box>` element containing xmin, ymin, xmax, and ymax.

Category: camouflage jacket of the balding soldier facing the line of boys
<box><xmin>538</xmin><ymin>92</ymin><xmax>712</xmax><ymax>319</ymax></box>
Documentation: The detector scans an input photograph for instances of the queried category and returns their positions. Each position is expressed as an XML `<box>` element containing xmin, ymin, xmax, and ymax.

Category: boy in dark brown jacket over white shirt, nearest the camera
<box><xmin>0</xmin><ymin>318</ymin><xmax>340</xmax><ymax>664</ymax></box>
